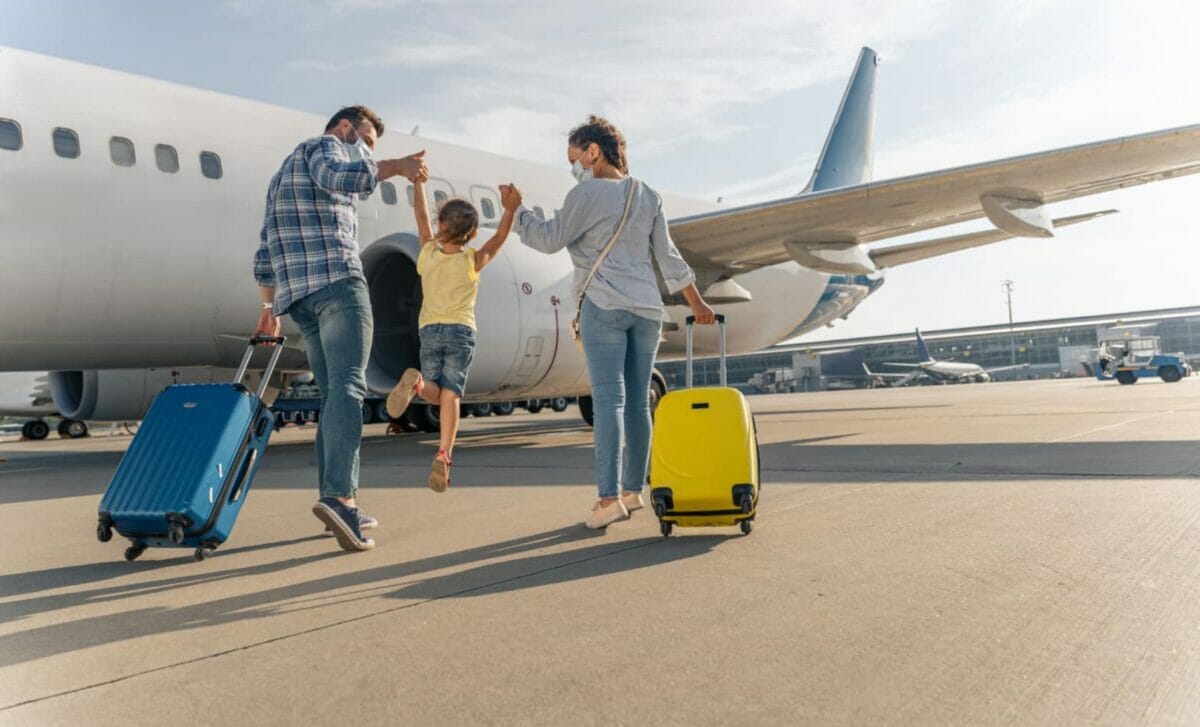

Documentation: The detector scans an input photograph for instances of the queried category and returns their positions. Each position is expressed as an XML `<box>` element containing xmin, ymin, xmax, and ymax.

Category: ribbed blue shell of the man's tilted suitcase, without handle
<box><xmin>100</xmin><ymin>384</ymin><xmax>257</xmax><ymax>530</ymax></box>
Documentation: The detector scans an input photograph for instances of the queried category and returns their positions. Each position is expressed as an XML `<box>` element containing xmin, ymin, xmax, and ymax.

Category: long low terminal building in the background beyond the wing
<box><xmin>659</xmin><ymin>306</ymin><xmax>1200</xmax><ymax>393</ymax></box>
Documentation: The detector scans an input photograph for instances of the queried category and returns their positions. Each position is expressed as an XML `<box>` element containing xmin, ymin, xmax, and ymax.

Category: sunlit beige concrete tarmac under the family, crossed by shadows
<box><xmin>0</xmin><ymin>379</ymin><xmax>1200</xmax><ymax>726</ymax></box>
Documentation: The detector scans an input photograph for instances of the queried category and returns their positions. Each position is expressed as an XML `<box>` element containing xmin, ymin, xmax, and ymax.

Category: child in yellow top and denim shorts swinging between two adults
<box><xmin>388</xmin><ymin>179</ymin><xmax>521</xmax><ymax>492</ymax></box>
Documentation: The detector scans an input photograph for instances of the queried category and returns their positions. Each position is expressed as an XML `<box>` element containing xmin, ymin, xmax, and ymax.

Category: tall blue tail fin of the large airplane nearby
<box><xmin>802</xmin><ymin>48</ymin><xmax>880</xmax><ymax>193</ymax></box>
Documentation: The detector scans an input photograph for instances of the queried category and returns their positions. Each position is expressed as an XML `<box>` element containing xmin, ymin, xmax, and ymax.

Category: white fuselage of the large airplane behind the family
<box><xmin>0</xmin><ymin>48</ymin><xmax>841</xmax><ymax>399</ymax></box>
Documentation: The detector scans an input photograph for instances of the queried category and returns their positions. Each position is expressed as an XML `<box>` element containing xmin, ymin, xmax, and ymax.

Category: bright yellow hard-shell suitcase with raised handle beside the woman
<box><xmin>650</xmin><ymin>316</ymin><xmax>761</xmax><ymax>536</ymax></box>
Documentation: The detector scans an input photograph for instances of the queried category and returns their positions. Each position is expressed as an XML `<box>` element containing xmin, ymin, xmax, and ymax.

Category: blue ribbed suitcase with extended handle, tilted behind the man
<box><xmin>96</xmin><ymin>337</ymin><xmax>284</xmax><ymax>560</ymax></box>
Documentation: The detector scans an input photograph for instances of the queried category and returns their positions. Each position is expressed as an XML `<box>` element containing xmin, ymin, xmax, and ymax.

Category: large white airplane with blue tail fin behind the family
<box><xmin>0</xmin><ymin>48</ymin><xmax>1200</xmax><ymax>420</ymax></box>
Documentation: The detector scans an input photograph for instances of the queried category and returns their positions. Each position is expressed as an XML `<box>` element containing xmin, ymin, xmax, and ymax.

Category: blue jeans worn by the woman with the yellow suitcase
<box><xmin>580</xmin><ymin>299</ymin><xmax>662</xmax><ymax>498</ymax></box>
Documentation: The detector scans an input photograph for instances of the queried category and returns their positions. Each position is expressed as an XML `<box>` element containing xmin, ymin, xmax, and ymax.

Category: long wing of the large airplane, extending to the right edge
<box><xmin>671</xmin><ymin>125</ymin><xmax>1200</xmax><ymax>274</ymax></box>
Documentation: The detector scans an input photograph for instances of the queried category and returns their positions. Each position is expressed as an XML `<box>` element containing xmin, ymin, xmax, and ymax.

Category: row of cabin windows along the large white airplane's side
<box><xmin>0</xmin><ymin>119</ymin><xmax>544</xmax><ymax>220</ymax></box>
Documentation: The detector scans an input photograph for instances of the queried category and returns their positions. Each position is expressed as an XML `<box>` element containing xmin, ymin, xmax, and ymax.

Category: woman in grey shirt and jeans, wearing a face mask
<box><xmin>514</xmin><ymin>116</ymin><xmax>714</xmax><ymax>529</ymax></box>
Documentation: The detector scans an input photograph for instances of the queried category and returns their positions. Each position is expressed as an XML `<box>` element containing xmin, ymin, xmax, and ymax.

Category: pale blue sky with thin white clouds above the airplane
<box><xmin>0</xmin><ymin>0</ymin><xmax>1200</xmax><ymax>341</ymax></box>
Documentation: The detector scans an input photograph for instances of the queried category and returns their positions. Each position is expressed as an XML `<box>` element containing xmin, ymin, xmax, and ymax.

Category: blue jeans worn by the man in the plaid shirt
<box><xmin>288</xmin><ymin>278</ymin><xmax>374</xmax><ymax>498</ymax></box>
